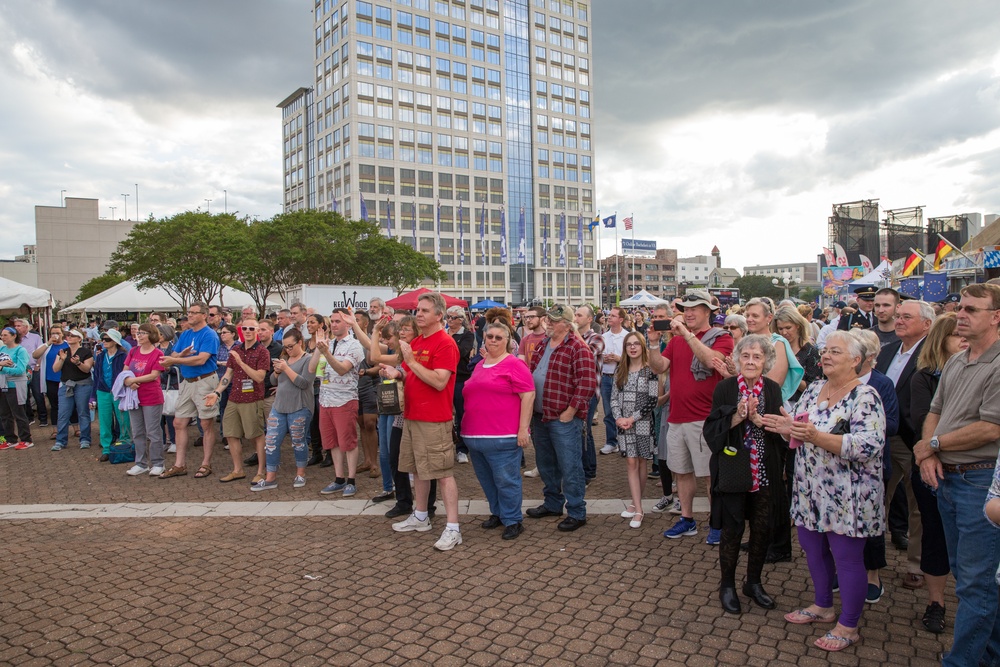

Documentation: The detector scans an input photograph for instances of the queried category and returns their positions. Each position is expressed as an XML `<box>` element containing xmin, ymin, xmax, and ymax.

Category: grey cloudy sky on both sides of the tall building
<box><xmin>0</xmin><ymin>0</ymin><xmax>1000</xmax><ymax>270</ymax></box>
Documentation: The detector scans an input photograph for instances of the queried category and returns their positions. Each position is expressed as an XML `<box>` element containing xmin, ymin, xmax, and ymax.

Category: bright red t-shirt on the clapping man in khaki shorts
<box><xmin>403</xmin><ymin>329</ymin><xmax>458</xmax><ymax>422</ymax></box>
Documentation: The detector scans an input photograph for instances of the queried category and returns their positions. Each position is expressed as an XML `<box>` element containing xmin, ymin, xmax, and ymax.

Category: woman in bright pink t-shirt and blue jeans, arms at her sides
<box><xmin>462</xmin><ymin>322</ymin><xmax>535</xmax><ymax>540</ymax></box>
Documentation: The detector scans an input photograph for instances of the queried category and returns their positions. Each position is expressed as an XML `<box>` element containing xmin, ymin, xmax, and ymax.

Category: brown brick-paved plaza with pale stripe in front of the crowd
<box><xmin>0</xmin><ymin>422</ymin><xmax>956</xmax><ymax>667</ymax></box>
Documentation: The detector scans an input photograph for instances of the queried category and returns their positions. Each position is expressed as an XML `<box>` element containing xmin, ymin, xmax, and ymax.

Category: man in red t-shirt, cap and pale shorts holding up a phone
<box><xmin>647</xmin><ymin>290</ymin><xmax>733</xmax><ymax>544</ymax></box>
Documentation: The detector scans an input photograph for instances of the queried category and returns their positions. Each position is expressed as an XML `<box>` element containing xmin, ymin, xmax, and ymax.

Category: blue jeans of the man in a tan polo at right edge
<box><xmin>937</xmin><ymin>470</ymin><xmax>1000</xmax><ymax>667</ymax></box>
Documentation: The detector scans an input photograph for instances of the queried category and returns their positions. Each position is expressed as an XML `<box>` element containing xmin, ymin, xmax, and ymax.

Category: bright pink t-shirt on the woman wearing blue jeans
<box><xmin>462</xmin><ymin>354</ymin><xmax>535</xmax><ymax>438</ymax></box>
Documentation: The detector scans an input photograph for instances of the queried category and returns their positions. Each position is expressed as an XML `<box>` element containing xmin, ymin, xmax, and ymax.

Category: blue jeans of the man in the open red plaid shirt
<box><xmin>531</xmin><ymin>414</ymin><xmax>587</xmax><ymax>520</ymax></box>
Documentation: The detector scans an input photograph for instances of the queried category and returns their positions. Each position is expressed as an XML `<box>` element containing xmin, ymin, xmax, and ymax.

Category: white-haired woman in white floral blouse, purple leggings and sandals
<box><xmin>764</xmin><ymin>332</ymin><xmax>885</xmax><ymax>651</ymax></box>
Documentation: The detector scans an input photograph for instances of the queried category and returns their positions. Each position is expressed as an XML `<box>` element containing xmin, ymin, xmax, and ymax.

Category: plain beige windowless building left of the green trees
<box><xmin>34</xmin><ymin>197</ymin><xmax>135</xmax><ymax>306</ymax></box>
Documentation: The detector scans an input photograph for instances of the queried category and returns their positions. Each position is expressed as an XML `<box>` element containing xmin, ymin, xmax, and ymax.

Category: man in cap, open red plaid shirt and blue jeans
<box><xmin>527</xmin><ymin>304</ymin><xmax>597</xmax><ymax>532</ymax></box>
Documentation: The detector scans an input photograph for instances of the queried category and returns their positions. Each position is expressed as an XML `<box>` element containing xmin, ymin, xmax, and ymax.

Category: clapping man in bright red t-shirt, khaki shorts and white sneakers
<box><xmin>381</xmin><ymin>292</ymin><xmax>462</xmax><ymax>551</ymax></box>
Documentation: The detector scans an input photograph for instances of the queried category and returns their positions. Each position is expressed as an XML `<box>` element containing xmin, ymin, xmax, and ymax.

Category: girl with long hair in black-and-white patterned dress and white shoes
<box><xmin>611</xmin><ymin>331</ymin><xmax>660</xmax><ymax>528</ymax></box>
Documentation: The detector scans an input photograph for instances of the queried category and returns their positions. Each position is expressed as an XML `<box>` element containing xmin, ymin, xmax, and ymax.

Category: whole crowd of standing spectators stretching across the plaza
<box><xmin>0</xmin><ymin>284</ymin><xmax>1000</xmax><ymax>665</ymax></box>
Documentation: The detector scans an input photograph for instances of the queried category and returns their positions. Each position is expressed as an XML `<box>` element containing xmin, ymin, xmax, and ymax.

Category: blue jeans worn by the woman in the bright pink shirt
<box><xmin>465</xmin><ymin>438</ymin><xmax>523</xmax><ymax>526</ymax></box>
